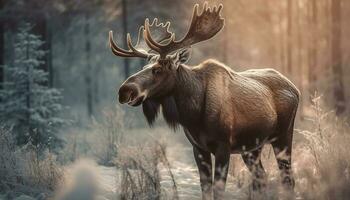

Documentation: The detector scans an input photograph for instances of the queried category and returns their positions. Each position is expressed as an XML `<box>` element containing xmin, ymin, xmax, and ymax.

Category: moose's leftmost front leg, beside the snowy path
<box><xmin>193</xmin><ymin>147</ymin><xmax>213</xmax><ymax>200</ymax></box>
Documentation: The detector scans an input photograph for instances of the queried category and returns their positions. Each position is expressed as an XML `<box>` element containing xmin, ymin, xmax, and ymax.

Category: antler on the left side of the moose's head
<box><xmin>109</xmin><ymin>18</ymin><xmax>171</xmax><ymax>58</ymax></box>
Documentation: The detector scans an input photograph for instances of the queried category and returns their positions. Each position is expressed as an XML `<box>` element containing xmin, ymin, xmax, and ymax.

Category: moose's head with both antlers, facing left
<box><xmin>109</xmin><ymin>3</ymin><xmax>224</xmax><ymax>106</ymax></box>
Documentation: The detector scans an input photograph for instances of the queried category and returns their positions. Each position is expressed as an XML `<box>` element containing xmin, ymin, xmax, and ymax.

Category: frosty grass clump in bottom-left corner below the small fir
<box><xmin>0</xmin><ymin>127</ymin><xmax>63</xmax><ymax>199</ymax></box>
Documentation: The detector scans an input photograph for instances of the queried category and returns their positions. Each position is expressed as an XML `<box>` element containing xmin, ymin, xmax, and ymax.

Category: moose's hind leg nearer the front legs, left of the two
<box><xmin>242</xmin><ymin>148</ymin><xmax>266</xmax><ymax>191</ymax></box>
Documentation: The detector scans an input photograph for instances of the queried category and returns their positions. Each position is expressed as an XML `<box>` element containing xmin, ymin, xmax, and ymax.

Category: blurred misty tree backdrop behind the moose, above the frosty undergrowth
<box><xmin>0</xmin><ymin>0</ymin><xmax>350</xmax><ymax>122</ymax></box>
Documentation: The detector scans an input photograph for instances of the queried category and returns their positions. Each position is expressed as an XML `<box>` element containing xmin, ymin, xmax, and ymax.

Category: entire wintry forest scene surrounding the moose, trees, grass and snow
<box><xmin>0</xmin><ymin>0</ymin><xmax>350</xmax><ymax>200</ymax></box>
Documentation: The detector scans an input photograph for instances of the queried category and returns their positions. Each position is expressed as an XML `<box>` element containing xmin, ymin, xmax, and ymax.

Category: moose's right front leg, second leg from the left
<box><xmin>214</xmin><ymin>148</ymin><xmax>230</xmax><ymax>199</ymax></box>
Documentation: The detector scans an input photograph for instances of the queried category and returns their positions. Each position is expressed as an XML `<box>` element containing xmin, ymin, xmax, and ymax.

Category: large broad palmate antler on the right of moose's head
<box><xmin>143</xmin><ymin>2</ymin><xmax>224</xmax><ymax>58</ymax></box>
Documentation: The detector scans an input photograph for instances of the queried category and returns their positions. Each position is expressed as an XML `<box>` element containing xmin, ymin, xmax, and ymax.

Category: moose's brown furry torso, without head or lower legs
<box><xmin>143</xmin><ymin>60</ymin><xmax>299</xmax><ymax>150</ymax></box>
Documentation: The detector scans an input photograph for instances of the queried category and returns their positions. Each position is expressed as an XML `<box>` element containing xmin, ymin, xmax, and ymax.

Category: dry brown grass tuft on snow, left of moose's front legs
<box><xmin>117</xmin><ymin>139</ymin><xmax>178</xmax><ymax>199</ymax></box>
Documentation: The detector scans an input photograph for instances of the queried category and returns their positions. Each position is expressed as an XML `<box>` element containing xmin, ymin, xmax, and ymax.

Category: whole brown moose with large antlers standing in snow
<box><xmin>109</xmin><ymin>3</ymin><xmax>300</xmax><ymax>199</ymax></box>
